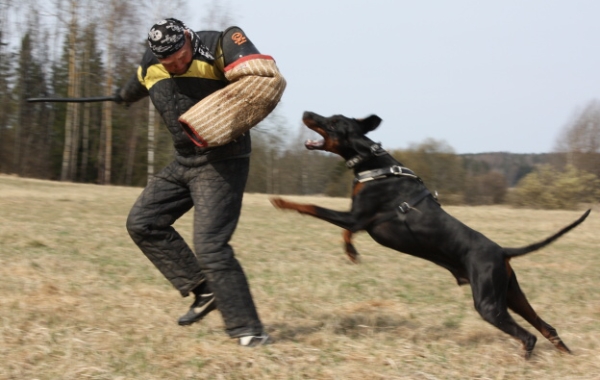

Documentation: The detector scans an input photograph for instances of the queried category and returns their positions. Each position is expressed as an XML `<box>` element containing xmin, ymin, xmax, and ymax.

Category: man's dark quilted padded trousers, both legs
<box><xmin>127</xmin><ymin>158</ymin><xmax>263</xmax><ymax>337</ymax></box>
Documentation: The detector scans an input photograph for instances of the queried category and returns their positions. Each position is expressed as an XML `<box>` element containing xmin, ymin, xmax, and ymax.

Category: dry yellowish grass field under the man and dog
<box><xmin>0</xmin><ymin>176</ymin><xmax>600</xmax><ymax>380</ymax></box>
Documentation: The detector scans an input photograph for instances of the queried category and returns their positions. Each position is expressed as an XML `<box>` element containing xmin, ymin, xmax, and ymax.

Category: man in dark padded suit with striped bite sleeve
<box><xmin>115</xmin><ymin>18</ymin><xmax>285</xmax><ymax>346</ymax></box>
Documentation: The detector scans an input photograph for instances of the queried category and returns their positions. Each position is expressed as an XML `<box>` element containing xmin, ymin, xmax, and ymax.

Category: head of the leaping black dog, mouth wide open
<box><xmin>302</xmin><ymin>111</ymin><xmax>381</xmax><ymax>159</ymax></box>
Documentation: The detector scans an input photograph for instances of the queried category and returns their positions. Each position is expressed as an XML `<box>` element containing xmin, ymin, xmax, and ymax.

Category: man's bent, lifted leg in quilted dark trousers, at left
<box><xmin>127</xmin><ymin>162</ymin><xmax>204</xmax><ymax>297</ymax></box>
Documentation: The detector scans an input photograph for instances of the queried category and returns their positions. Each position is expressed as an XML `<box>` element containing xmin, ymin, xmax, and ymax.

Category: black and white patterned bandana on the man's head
<box><xmin>148</xmin><ymin>18</ymin><xmax>188</xmax><ymax>59</ymax></box>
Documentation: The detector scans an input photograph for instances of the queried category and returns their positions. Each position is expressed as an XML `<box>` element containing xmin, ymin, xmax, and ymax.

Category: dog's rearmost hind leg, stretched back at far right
<box><xmin>506</xmin><ymin>263</ymin><xmax>571</xmax><ymax>354</ymax></box>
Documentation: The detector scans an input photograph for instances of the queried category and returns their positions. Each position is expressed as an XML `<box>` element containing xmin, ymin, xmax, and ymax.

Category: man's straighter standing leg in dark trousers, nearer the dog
<box><xmin>189</xmin><ymin>158</ymin><xmax>263</xmax><ymax>338</ymax></box>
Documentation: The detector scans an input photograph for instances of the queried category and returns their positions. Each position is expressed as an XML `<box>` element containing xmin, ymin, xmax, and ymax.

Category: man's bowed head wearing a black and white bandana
<box><xmin>148</xmin><ymin>18</ymin><xmax>193</xmax><ymax>75</ymax></box>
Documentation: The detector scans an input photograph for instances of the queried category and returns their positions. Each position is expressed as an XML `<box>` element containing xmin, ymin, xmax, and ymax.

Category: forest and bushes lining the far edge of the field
<box><xmin>0</xmin><ymin>0</ymin><xmax>600</xmax><ymax>208</ymax></box>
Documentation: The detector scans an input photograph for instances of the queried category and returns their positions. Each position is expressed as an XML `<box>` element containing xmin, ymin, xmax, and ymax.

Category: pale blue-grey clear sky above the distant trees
<box><xmin>178</xmin><ymin>0</ymin><xmax>600</xmax><ymax>154</ymax></box>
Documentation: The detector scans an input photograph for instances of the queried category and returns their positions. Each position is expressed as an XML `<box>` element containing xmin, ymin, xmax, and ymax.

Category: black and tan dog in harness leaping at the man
<box><xmin>271</xmin><ymin>112</ymin><xmax>590</xmax><ymax>358</ymax></box>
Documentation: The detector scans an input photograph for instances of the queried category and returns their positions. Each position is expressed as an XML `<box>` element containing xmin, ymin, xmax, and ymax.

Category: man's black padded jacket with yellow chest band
<box><xmin>119</xmin><ymin>27</ymin><xmax>259</xmax><ymax>166</ymax></box>
